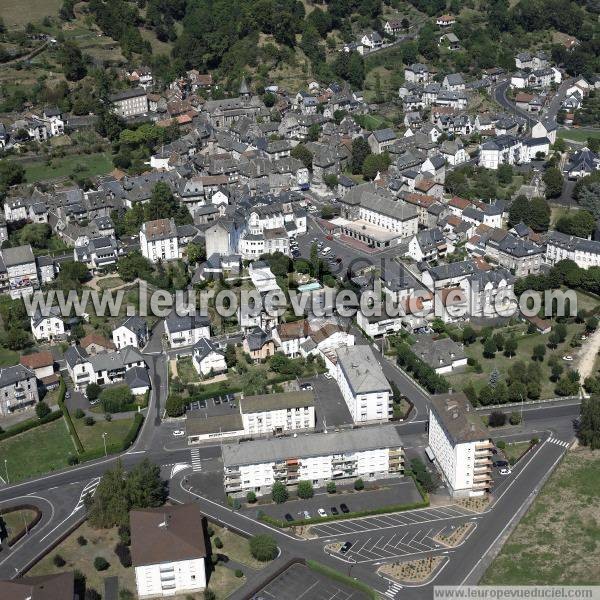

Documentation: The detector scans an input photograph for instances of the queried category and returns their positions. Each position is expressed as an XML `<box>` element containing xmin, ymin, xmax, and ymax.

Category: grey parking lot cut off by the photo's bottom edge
<box><xmin>253</xmin><ymin>564</ymin><xmax>368</xmax><ymax>600</ymax></box>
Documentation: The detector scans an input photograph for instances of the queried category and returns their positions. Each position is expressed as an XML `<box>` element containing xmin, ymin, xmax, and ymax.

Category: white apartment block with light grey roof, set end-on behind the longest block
<box><xmin>335</xmin><ymin>346</ymin><xmax>393</xmax><ymax>423</ymax></box>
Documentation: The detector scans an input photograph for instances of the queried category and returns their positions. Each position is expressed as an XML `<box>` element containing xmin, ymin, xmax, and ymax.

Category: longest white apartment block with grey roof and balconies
<box><xmin>222</xmin><ymin>426</ymin><xmax>404</xmax><ymax>495</ymax></box>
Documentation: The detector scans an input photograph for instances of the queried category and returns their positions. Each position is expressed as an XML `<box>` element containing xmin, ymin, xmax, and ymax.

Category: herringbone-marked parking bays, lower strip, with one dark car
<box><xmin>332</xmin><ymin>524</ymin><xmax>472</xmax><ymax>563</ymax></box>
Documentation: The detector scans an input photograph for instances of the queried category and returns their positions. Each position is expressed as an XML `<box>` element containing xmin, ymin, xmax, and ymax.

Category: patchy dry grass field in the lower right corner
<box><xmin>481</xmin><ymin>449</ymin><xmax>600</xmax><ymax>585</ymax></box>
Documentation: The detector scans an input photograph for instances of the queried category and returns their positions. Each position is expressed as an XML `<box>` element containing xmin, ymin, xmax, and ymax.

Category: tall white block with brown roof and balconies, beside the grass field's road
<box><xmin>429</xmin><ymin>393</ymin><xmax>493</xmax><ymax>497</ymax></box>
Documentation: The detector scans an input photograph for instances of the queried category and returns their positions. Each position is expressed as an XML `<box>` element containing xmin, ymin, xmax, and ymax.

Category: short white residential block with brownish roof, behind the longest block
<box><xmin>240</xmin><ymin>392</ymin><xmax>315</xmax><ymax>435</ymax></box>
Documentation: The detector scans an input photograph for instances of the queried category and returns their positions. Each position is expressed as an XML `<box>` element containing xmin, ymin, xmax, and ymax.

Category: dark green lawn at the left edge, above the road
<box><xmin>0</xmin><ymin>418</ymin><xmax>75</xmax><ymax>483</ymax></box>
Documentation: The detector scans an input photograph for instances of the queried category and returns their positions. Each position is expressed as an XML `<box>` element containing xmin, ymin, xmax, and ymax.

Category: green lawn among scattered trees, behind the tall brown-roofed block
<box><xmin>445</xmin><ymin>323</ymin><xmax>584</xmax><ymax>398</ymax></box>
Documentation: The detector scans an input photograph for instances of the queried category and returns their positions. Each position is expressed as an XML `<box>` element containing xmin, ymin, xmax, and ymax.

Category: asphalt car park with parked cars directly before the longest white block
<box><xmin>241</xmin><ymin>478</ymin><xmax>421</xmax><ymax>527</ymax></box>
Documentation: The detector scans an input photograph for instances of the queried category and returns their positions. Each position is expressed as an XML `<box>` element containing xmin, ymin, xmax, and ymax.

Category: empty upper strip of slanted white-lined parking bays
<box><xmin>312</xmin><ymin>505</ymin><xmax>474</xmax><ymax>537</ymax></box>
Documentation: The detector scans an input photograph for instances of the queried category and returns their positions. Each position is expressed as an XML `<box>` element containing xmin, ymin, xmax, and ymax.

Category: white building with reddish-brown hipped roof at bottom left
<box><xmin>129</xmin><ymin>504</ymin><xmax>206</xmax><ymax>598</ymax></box>
